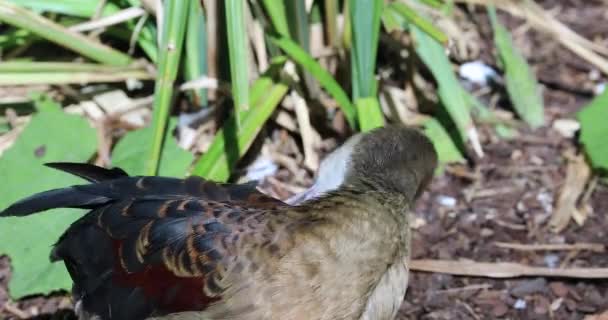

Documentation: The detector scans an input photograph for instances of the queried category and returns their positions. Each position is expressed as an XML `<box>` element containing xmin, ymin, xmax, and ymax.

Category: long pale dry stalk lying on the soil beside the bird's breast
<box><xmin>409</xmin><ymin>259</ymin><xmax>608</xmax><ymax>279</ymax></box>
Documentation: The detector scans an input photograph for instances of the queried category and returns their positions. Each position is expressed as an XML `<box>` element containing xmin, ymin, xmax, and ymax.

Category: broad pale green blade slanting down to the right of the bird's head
<box><xmin>411</xmin><ymin>25</ymin><xmax>473</xmax><ymax>141</ymax></box>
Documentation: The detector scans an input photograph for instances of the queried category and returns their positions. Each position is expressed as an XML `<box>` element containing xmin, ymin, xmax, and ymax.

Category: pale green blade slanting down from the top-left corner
<box><xmin>0</xmin><ymin>0</ymin><xmax>132</xmax><ymax>66</ymax></box>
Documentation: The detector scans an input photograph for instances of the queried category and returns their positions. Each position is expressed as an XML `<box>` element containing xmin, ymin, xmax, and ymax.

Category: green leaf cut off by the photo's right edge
<box><xmin>577</xmin><ymin>90</ymin><xmax>608</xmax><ymax>171</ymax></box>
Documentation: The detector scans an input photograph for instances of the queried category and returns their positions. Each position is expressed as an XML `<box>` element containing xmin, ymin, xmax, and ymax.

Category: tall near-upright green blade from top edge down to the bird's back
<box><xmin>146</xmin><ymin>0</ymin><xmax>193</xmax><ymax>175</ymax></box>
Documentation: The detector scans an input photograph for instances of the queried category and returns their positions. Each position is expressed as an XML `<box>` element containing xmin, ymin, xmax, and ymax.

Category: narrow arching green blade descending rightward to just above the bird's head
<box><xmin>271</xmin><ymin>37</ymin><xmax>357</xmax><ymax>129</ymax></box>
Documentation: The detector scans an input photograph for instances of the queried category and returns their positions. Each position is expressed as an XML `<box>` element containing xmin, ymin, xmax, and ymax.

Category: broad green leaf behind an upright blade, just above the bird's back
<box><xmin>112</xmin><ymin>118</ymin><xmax>194</xmax><ymax>177</ymax></box>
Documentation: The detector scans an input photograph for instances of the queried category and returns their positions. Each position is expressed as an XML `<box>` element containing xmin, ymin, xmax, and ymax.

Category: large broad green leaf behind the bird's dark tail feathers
<box><xmin>0</xmin><ymin>95</ymin><xmax>97</xmax><ymax>299</ymax></box>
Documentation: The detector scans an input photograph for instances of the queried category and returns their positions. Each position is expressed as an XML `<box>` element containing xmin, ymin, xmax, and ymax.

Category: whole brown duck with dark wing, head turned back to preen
<box><xmin>0</xmin><ymin>127</ymin><xmax>436</xmax><ymax>320</ymax></box>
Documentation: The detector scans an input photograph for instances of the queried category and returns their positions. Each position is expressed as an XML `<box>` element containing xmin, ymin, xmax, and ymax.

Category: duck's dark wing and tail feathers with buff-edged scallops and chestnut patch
<box><xmin>0</xmin><ymin>164</ymin><xmax>284</xmax><ymax>319</ymax></box>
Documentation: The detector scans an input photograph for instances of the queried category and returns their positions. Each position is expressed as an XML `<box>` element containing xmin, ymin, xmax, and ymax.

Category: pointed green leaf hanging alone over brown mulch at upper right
<box><xmin>488</xmin><ymin>7</ymin><xmax>545</xmax><ymax>128</ymax></box>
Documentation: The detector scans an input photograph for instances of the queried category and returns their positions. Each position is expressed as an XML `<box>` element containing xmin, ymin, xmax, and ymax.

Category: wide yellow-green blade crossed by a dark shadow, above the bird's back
<box><xmin>193</xmin><ymin>66</ymin><xmax>289</xmax><ymax>181</ymax></box>
